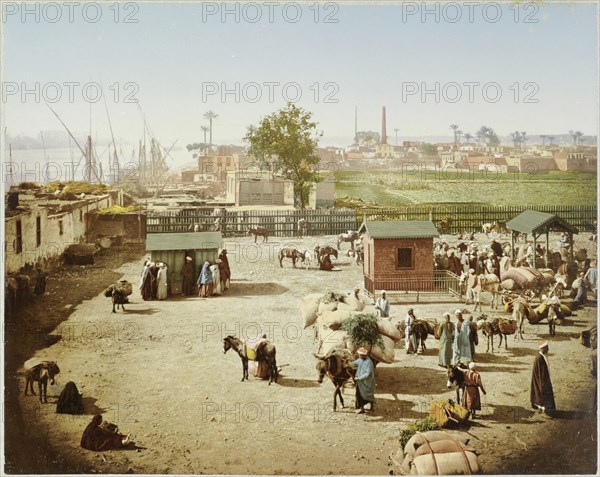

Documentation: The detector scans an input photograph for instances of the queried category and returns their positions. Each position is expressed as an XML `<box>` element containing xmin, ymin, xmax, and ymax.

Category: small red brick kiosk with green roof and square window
<box><xmin>359</xmin><ymin>221</ymin><xmax>439</xmax><ymax>296</ymax></box>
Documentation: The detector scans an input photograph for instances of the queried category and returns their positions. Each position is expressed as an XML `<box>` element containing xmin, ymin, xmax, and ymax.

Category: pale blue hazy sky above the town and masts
<box><xmin>2</xmin><ymin>1</ymin><xmax>599</xmax><ymax>149</ymax></box>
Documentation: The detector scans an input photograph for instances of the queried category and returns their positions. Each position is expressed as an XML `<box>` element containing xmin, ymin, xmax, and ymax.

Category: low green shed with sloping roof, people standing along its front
<box><xmin>146</xmin><ymin>232</ymin><xmax>223</xmax><ymax>294</ymax></box>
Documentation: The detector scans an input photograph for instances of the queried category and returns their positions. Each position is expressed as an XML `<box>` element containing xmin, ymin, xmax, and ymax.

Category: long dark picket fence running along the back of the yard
<box><xmin>146</xmin><ymin>204</ymin><xmax>597</xmax><ymax>237</ymax></box>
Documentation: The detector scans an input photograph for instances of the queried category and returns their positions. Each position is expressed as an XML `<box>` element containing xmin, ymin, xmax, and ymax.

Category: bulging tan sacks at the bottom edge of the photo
<box><xmin>388</xmin><ymin>431</ymin><xmax>481</xmax><ymax>475</ymax></box>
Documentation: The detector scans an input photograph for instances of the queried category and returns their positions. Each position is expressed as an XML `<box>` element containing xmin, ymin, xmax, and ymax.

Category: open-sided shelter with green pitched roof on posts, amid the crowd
<box><xmin>506</xmin><ymin>210</ymin><xmax>579</xmax><ymax>268</ymax></box>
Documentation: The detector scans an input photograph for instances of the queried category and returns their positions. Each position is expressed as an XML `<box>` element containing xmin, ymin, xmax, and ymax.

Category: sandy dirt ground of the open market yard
<box><xmin>4</xmin><ymin>231</ymin><xmax>597</xmax><ymax>475</ymax></box>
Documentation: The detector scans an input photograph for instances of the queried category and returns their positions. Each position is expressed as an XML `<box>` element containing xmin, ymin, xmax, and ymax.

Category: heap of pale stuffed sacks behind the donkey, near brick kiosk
<box><xmin>300</xmin><ymin>292</ymin><xmax>402</xmax><ymax>364</ymax></box>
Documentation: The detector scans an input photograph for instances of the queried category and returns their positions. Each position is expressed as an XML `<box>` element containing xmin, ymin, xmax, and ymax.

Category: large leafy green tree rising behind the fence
<box><xmin>244</xmin><ymin>103</ymin><xmax>323</xmax><ymax>208</ymax></box>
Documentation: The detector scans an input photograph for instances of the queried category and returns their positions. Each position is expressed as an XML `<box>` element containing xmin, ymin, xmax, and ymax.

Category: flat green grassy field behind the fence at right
<box><xmin>335</xmin><ymin>170</ymin><xmax>597</xmax><ymax>207</ymax></box>
